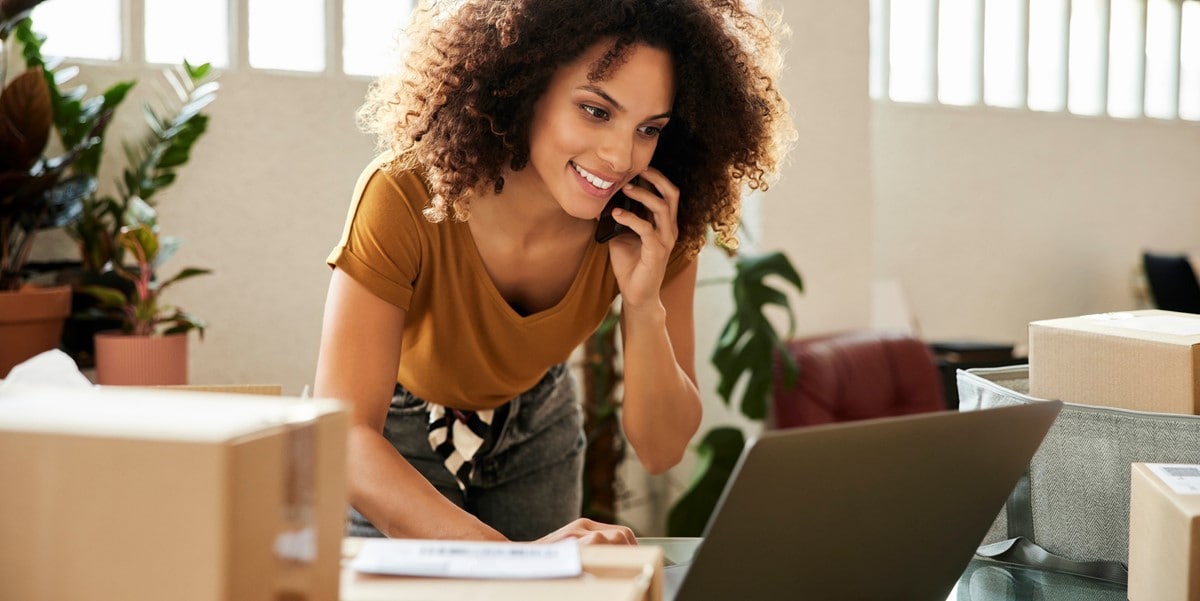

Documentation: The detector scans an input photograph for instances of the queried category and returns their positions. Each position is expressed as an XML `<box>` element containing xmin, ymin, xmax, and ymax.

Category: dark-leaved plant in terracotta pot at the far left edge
<box><xmin>0</xmin><ymin>0</ymin><xmax>112</xmax><ymax>378</ymax></box>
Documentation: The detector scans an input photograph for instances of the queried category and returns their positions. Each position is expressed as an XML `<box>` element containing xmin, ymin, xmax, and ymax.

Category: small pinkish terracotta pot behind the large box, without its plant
<box><xmin>96</xmin><ymin>332</ymin><xmax>187</xmax><ymax>386</ymax></box>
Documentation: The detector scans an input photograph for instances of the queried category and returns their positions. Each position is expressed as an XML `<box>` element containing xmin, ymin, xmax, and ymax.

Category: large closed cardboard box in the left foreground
<box><xmin>0</xmin><ymin>387</ymin><xmax>348</xmax><ymax>601</ymax></box>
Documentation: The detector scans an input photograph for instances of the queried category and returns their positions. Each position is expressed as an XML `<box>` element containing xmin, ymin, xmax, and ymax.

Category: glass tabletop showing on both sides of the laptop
<box><xmin>638</xmin><ymin>537</ymin><xmax>1127</xmax><ymax>601</ymax></box>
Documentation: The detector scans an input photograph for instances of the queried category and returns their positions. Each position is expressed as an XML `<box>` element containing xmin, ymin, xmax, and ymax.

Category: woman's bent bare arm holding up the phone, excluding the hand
<box><xmin>620</xmin><ymin>262</ymin><xmax>701</xmax><ymax>474</ymax></box>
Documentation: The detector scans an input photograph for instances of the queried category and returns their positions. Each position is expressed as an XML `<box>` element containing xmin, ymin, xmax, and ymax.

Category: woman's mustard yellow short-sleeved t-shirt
<box><xmin>328</xmin><ymin>157</ymin><xmax>689</xmax><ymax>410</ymax></box>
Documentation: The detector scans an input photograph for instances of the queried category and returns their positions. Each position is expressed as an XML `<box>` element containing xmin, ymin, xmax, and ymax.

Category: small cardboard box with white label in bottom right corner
<box><xmin>1129</xmin><ymin>463</ymin><xmax>1200</xmax><ymax>601</ymax></box>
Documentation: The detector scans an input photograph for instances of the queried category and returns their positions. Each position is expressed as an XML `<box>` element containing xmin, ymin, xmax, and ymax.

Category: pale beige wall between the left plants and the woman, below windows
<box><xmin>32</xmin><ymin>66</ymin><xmax>374</xmax><ymax>395</ymax></box>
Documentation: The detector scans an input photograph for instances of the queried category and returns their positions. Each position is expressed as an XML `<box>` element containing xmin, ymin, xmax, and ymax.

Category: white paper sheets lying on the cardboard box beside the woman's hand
<box><xmin>350</xmin><ymin>539</ymin><xmax>583</xmax><ymax>579</ymax></box>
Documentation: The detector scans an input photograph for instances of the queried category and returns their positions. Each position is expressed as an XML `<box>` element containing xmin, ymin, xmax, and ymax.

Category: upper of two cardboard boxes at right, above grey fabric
<box><xmin>1030</xmin><ymin>311</ymin><xmax>1200</xmax><ymax>415</ymax></box>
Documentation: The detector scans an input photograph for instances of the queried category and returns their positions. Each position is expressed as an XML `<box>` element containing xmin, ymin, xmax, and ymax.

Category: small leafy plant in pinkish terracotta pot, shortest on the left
<box><xmin>83</xmin><ymin>223</ymin><xmax>210</xmax><ymax>385</ymax></box>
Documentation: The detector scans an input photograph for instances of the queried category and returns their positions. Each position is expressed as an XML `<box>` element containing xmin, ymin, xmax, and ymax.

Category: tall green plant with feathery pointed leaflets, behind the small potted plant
<box><xmin>14</xmin><ymin>19</ymin><xmax>220</xmax><ymax>367</ymax></box>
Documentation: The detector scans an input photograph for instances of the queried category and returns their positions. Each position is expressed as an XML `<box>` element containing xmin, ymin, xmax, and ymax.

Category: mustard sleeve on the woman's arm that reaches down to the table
<box><xmin>326</xmin><ymin>160</ymin><xmax>428</xmax><ymax>311</ymax></box>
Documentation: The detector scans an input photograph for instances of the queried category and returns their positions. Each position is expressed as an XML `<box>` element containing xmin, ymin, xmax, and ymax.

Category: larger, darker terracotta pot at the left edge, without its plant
<box><xmin>0</xmin><ymin>286</ymin><xmax>71</xmax><ymax>378</ymax></box>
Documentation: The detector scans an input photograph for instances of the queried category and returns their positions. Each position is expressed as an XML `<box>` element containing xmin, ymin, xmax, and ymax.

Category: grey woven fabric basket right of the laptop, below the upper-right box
<box><xmin>958</xmin><ymin>366</ymin><xmax>1200</xmax><ymax>582</ymax></box>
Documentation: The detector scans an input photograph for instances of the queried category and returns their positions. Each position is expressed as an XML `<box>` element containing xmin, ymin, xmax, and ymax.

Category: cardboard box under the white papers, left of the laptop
<box><xmin>340</xmin><ymin>539</ymin><xmax>662</xmax><ymax>601</ymax></box>
